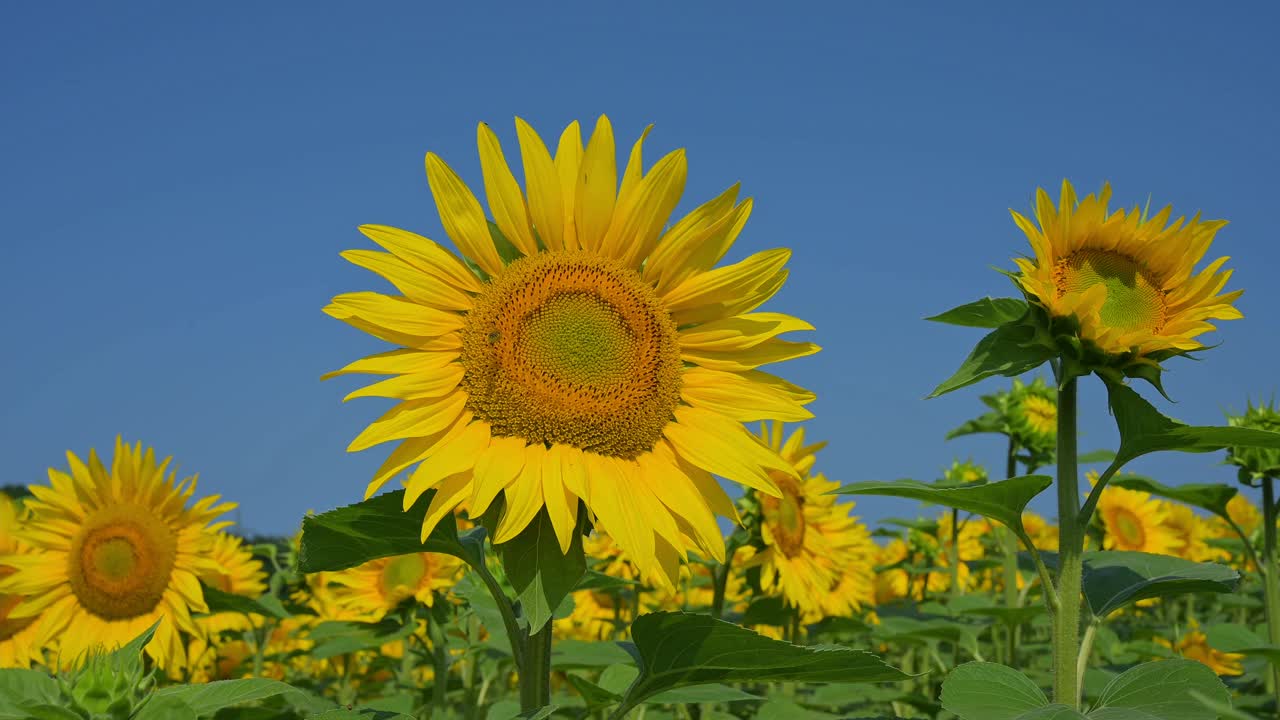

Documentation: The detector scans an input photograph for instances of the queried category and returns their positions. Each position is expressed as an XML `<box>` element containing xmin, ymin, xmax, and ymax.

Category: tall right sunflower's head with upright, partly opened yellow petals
<box><xmin>1011</xmin><ymin>181</ymin><xmax>1242</xmax><ymax>363</ymax></box>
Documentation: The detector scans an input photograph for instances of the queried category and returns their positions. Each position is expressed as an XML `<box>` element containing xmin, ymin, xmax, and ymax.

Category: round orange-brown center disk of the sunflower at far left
<box><xmin>69</xmin><ymin>506</ymin><xmax>177</xmax><ymax>620</ymax></box>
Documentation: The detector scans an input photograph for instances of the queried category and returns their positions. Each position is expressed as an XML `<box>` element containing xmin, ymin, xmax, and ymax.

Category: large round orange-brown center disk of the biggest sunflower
<box><xmin>462</xmin><ymin>252</ymin><xmax>681</xmax><ymax>459</ymax></box>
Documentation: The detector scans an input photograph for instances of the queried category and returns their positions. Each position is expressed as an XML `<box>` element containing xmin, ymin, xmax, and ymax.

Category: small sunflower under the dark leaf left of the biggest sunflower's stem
<box><xmin>329</xmin><ymin>552</ymin><xmax>462</xmax><ymax>621</ymax></box>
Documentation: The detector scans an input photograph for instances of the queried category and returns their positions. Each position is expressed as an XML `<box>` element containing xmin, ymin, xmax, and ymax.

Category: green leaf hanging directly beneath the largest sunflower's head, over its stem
<box><xmin>498</xmin><ymin>507</ymin><xmax>586</xmax><ymax>630</ymax></box>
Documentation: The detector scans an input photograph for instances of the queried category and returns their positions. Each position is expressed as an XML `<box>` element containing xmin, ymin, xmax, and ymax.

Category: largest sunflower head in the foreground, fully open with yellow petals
<box><xmin>325</xmin><ymin>117</ymin><xmax>818</xmax><ymax>582</ymax></box>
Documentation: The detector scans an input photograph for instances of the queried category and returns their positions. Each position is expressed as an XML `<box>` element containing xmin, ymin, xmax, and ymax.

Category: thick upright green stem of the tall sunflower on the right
<box><xmin>1053</xmin><ymin>377</ymin><xmax>1084</xmax><ymax>710</ymax></box>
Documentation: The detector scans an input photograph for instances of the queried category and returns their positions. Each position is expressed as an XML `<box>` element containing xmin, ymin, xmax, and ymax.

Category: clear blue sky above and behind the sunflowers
<box><xmin>0</xmin><ymin>3</ymin><xmax>1280</xmax><ymax>532</ymax></box>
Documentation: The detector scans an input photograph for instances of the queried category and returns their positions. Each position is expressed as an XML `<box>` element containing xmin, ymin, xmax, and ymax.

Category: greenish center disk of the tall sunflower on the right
<box><xmin>1055</xmin><ymin>250</ymin><xmax>1165</xmax><ymax>332</ymax></box>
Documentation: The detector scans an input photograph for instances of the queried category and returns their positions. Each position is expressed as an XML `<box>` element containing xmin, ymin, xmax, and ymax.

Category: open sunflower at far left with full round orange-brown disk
<box><xmin>0</xmin><ymin>438</ymin><xmax>236</xmax><ymax>673</ymax></box>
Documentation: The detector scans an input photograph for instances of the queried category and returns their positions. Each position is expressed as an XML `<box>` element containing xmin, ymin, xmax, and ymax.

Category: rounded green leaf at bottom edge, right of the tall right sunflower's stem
<box><xmin>1089</xmin><ymin>660</ymin><xmax>1231</xmax><ymax>720</ymax></box>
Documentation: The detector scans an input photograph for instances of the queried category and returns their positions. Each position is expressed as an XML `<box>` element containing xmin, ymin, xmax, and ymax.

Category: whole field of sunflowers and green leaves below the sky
<box><xmin>0</xmin><ymin>117</ymin><xmax>1280</xmax><ymax>720</ymax></box>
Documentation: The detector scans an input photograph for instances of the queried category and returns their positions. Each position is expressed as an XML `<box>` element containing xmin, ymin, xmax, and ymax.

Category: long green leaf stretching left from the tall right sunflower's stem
<box><xmin>836</xmin><ymin>475</ymin><xmax>1053</xmax><ymax>544</ymax></box>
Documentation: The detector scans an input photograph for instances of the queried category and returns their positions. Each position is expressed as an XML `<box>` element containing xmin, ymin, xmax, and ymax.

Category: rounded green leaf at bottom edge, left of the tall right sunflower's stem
<box><xmin>942</xmin><ymin>662</ymin><xmax>1048</xmax><ymax>720</ymax></box>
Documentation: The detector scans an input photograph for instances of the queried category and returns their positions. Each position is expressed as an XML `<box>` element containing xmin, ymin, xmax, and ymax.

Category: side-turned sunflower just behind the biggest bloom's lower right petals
<box><xmin>749</xmin><ymin>423</ymin><xmax>874</xmax><ymax>618</ymax></box>
